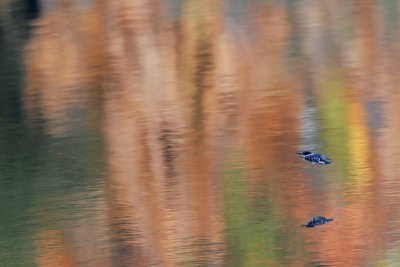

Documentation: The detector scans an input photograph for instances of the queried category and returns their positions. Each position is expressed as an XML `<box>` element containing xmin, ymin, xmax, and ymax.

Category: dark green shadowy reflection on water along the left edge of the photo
<box><xmin>0</xmin><ymin>39</ymin><xmax>105</xmax><ymax>267</ymax></box>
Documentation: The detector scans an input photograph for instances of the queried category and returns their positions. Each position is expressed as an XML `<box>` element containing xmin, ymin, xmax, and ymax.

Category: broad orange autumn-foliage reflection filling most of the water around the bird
<box><xmin>20</xmin><ymin>0</ymin><xmax>400</xmax><ymax>266</ymax></box>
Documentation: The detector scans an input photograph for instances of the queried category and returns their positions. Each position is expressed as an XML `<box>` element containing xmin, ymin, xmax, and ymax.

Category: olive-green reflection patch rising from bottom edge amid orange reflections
<box><xmin>222</xmin><ymin>160</ymin><xmax>294</xmax><ymax>266</ymax></box>
